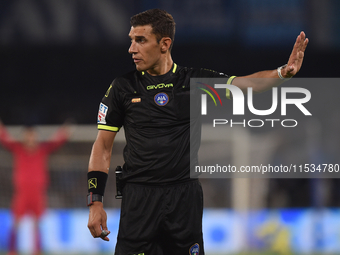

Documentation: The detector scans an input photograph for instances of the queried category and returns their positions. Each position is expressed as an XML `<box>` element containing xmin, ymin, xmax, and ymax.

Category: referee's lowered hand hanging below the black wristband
<box><xmin>87</xmin><ymin>201</ymin><xmax>110</xmax><ymax>241</ymax></box>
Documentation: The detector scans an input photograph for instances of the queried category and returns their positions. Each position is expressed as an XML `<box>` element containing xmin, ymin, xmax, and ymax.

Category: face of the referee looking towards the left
<box><xmin>129</xmin><ymin>25</ymin><xmax>162</xmax><ymax>73</ymax></box>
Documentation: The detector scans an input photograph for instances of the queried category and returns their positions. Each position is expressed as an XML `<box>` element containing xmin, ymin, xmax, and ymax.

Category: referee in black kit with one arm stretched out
<box><xmin>88</xmin><ymin>9</ymin><xmax>308</xmax><ymax>255</ymax></box>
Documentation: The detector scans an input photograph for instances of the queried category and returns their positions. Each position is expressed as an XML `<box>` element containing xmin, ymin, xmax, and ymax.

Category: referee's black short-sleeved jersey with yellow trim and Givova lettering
<box><xmin>98</xmin><ymin>63</ymin><xmax>234</xmax><ymax>184</ymax></box>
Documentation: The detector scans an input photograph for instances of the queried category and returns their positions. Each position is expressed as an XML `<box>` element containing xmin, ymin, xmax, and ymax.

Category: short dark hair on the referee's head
<box><xmin>130</xmin><ymin>9</ymin><xmax>176</xmax><ymax>51</ymax></box>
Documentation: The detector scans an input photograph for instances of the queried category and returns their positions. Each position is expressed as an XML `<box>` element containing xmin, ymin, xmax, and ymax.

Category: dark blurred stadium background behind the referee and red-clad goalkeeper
<box><xmin>0</xmin><ymin>0</ymin><xmax>340</xmax><ymax>255</ymax></box>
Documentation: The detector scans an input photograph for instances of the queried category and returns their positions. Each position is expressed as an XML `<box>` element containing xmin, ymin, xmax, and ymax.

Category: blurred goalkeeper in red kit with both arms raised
<box><xmin>0</xmin><ymin>120</ymin><xmax>70</xmax><ymax>255</ymax></box>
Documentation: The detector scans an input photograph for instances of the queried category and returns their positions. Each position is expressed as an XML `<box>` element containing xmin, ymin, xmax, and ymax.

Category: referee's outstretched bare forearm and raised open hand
<box><xmin>232</xmin><ymin>32</ymin><xmax>308</xmax><ymax>93</ymax></box>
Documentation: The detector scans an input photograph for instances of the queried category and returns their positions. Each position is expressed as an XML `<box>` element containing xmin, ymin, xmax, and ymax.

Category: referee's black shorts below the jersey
<box><xmin>115</xmin><ymin>180</ymin><xmax>204</xmax><ymax>255</ymax></box>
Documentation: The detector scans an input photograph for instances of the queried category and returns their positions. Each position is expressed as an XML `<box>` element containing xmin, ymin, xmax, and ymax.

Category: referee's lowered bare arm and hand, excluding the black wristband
<box><xmin>87</xmin><ymin>130</ymin><xmax>117</xmax><ymax>241</ymax></box>
